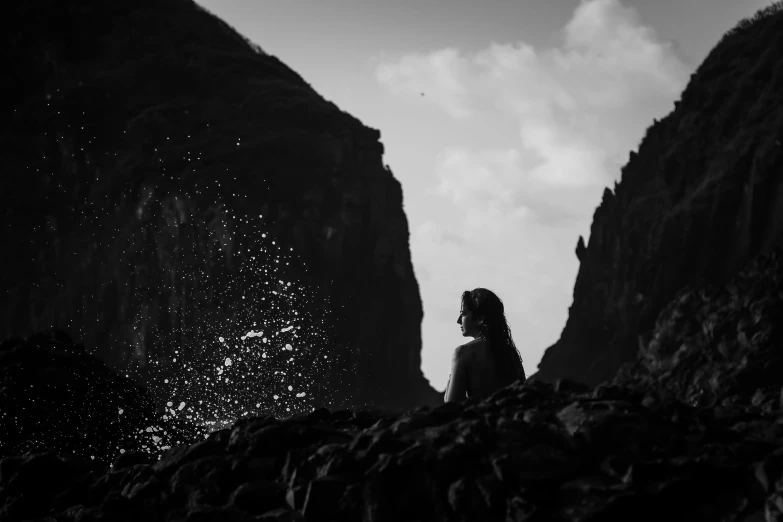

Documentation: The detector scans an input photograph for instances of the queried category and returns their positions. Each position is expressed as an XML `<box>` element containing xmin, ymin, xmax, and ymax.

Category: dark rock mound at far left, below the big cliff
<box><xmin>0</xmin><ymin>332</ymin><xmax>209</xmax><ymax>466</ymax></box>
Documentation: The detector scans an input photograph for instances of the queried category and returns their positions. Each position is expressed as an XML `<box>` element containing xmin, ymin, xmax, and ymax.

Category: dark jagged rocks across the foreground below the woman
<box><xmin>0</xmin><ymin>374</ymin><xmax>783</xmax><ymax>522</ymax></box>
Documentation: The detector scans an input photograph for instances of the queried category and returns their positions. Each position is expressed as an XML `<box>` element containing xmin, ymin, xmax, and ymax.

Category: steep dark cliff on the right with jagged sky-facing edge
<box><xmin>535</xmin><ymin>3</ymin><xmax>783</xmax><ymax>385</ymax></box>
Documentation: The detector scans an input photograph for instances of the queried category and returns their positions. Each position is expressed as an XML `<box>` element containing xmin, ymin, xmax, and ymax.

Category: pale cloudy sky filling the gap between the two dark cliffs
<box><xmin>197</xmin><ymin>0</ymin><xmax>771</xmax><ymax>390</ymax></box>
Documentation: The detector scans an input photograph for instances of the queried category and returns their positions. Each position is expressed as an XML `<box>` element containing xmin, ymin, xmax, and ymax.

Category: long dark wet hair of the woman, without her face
<box><xmin>462</xmin><ymin>288</ymin><xmax>525</xmax><ymax>384</ymax></box>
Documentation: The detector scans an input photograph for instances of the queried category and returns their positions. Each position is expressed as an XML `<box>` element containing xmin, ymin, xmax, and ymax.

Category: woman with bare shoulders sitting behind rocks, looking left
<box><xmin>444</xmin><ymin>288</ymin><xmax>525</xmax><ymax>402</ymax></box>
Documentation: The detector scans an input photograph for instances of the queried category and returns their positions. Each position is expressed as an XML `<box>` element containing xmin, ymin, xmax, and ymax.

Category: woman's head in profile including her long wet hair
<box><xmin>457</xmin><ymin>288</ymin><xmax>524</xmax><ymax>379</ymax></box>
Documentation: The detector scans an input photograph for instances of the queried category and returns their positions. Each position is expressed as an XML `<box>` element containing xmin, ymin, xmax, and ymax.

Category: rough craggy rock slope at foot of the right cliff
<box><xmin>615</xmin><ymin>238</ymin><xmax>783</xmax><ymax>408</ymax></box>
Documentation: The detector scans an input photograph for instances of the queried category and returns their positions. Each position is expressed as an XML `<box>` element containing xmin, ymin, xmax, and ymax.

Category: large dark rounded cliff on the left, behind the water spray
<box><xmin>0</xmin><ymin>0</ymin><xmax>441</xmax><ymax>418</ymax></box>
